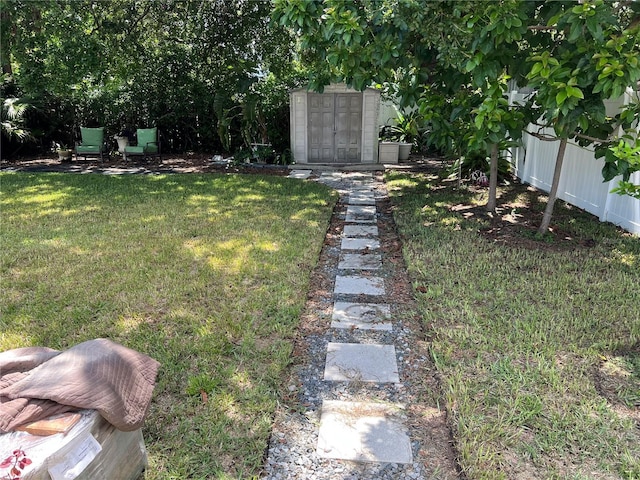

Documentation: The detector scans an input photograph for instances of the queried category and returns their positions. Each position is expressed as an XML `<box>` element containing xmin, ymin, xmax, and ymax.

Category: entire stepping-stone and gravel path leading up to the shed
<box><xmin>266</xmin><ymin>172</ymin><xmax>424</xmax><ymax>480</ymax></box>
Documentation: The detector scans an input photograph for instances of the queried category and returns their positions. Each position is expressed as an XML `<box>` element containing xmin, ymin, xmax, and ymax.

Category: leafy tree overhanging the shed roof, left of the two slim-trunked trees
<box><xmin>274</xmin><ymin>0</ymin><xmax>533</xmax><ymax>210</ymax></box>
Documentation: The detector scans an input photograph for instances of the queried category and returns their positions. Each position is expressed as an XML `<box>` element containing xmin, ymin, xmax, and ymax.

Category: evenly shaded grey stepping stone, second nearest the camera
<box><xmin>324</xmin><ymin>342</ymin><xmax>400</xmax><ymax>383</ymax></box>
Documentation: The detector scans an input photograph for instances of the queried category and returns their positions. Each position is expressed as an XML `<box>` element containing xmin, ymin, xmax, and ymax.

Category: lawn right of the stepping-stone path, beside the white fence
<box><xmin>387</xmin><ymin>172</ymin><xmax>640</xmax><ymax>480</ymax></box>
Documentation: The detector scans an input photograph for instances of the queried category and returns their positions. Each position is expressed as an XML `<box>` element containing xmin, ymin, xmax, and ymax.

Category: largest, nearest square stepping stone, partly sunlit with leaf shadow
<box><xmin>317</xmin><ymin>400</ymin><xmax>413</xmax><ymax>463</ymax></box>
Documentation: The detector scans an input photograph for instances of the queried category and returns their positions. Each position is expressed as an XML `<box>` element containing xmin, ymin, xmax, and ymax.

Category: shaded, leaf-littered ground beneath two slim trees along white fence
<box><xmin>387</xmin><ymin>171</ymin><xmax>640</xmax><ymax>268</ymax></box>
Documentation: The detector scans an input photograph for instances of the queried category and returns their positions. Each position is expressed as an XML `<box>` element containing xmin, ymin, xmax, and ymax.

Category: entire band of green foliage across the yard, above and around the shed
<box><xmin>5</xmin><ymin>0</ymin><xmax>640</xmax><ymax>214</ymax></box>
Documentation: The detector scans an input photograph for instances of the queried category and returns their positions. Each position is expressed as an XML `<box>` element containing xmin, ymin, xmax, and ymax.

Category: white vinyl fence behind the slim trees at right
<box><xmin>507</xmin><ymin>92</ymin><xmax>640</xmax><ymax>235</ymax></box>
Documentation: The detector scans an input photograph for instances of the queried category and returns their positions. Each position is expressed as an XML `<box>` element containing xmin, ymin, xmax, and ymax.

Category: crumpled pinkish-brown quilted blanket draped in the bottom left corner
<box><xmin>0</xmin><ymin>338</ymin><xmax>160</xmax><ymax>433</ymax></box>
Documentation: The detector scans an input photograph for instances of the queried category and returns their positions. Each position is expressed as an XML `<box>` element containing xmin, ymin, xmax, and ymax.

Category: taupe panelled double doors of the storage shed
<box><xmin>307</xmin><ymin>93</ymin><xmax>362</xmax><ymax>163</ymax></box>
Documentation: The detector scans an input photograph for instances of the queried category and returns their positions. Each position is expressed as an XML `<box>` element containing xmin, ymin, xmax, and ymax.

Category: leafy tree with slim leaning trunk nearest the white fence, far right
<box><xmin>527</xmin><ymin>0</ymin><xmax>640</xmax><ymax>234</ymax></box>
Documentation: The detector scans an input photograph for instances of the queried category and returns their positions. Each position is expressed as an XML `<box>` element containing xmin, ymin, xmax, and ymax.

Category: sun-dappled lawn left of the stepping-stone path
<box><xmin>0</xmin><ymin>173</ymin><xmax>337</xmax><ymax>480</ymax></box>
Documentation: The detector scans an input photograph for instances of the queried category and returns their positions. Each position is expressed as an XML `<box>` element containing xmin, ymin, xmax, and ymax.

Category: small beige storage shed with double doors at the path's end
<box><xmin>290</xmin><ymin>83</ymin><xmax>380</xmax><ymax>165</ymax></box>
